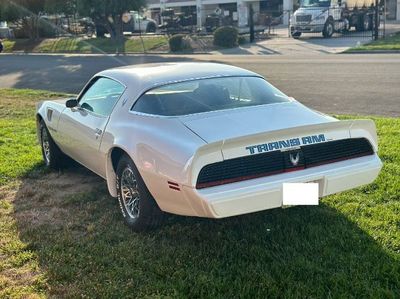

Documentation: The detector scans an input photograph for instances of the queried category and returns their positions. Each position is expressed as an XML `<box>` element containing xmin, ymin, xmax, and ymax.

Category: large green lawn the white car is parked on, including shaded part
<box><xmin>0</xmin><ymin>90</ymin><xmax>400</xmax><ymax>298</ymax></box>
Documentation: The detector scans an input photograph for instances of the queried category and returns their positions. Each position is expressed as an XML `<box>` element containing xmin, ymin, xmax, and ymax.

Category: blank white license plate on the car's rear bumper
<box><xmin>282</xmin><ymin>183</ymin><xmax>319</xmax><ymax>206</ymax></box>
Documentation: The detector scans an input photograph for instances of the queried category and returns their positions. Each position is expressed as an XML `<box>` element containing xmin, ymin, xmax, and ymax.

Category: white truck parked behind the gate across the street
<box><xmin>290</xmin><ymin>0</ymin><xmax>379</xmax><ymax>38</ymax></box>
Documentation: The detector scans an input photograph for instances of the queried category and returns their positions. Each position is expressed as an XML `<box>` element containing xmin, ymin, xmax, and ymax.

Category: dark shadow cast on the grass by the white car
<box><xmin>9</xmin><ymin>166</ymin><xmax>400</xmax><ymax>298</ymax></box>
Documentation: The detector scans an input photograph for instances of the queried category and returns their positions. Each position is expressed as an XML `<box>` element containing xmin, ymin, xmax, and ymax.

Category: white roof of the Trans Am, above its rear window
<box><xmin>96</xmin><ymin>62</ymin><xmax>261</xmax><ymax>90</ymax></box>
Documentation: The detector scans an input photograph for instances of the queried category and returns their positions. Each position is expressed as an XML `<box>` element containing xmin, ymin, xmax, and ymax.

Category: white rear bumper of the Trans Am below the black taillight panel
<box><xmin>182</xmin><ymin>154</ymin><xmax>382</xmax><ymax>218</ymax></box>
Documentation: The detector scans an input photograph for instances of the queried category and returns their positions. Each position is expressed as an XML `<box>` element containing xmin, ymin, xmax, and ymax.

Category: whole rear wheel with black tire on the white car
<box><xmin>117</xmin><ymin>155</ymin><xmax>164</xmax><ymax>231</ymax></box>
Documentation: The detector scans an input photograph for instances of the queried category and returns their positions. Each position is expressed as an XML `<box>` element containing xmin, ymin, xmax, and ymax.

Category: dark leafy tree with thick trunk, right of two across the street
<box><xmin>77</xmin><ymin>0</ymin><xmax>145</xmax><ymax>39</ymax></box>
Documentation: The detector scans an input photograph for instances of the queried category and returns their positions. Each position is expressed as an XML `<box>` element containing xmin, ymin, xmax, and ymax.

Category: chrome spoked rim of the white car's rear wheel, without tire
<box><xmin>121</xmin><ymin>167</ymin><xmax>140</xmax><ymax>219</ymax></box>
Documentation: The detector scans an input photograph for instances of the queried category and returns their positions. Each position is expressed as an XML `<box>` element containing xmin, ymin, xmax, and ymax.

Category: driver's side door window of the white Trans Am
<box><xmin>79</xmin><ymin>77</ymin><xmax>125</xmax><ymax>116</ymax></box>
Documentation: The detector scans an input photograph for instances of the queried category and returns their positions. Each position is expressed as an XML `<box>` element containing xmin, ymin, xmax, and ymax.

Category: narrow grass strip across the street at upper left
<box><xmin>4</xmin><ymin>36</ymin><xmax>168</xmax><ymax>53</ymax></box>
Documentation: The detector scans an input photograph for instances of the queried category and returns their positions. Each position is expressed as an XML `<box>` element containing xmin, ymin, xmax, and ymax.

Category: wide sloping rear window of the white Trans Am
<box><xmin>132</xmin><ymin>77</ymin><xmax>289</xmax><ymax>116</ymax></box>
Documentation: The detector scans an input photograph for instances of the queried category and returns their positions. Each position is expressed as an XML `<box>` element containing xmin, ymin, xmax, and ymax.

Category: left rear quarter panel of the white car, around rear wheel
<box><xmin>100</xmin><ymin>101</ymin><xmax>205</xmax><ymax>215</ymax></box>
